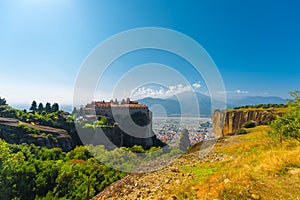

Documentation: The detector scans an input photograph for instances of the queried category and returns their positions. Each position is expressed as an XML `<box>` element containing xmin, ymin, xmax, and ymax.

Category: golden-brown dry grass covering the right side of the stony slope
<box><xmin>189</xmin><ymin>126</ymin><xmax>300</xmax><ymax>199</ymax></box>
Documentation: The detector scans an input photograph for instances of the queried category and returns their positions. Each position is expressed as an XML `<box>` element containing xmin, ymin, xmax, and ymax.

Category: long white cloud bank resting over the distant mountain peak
<box><xmin>130</xmin><ymin>83</ymin><xmax>196</xmax><ymax>99</ymax></box>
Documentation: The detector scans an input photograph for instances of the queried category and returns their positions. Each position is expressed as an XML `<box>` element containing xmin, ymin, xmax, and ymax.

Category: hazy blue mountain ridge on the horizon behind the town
<box><xmin>138</xmin><ymin>92</ymin><xmax>286</xmax><ymax>117</ymax></box>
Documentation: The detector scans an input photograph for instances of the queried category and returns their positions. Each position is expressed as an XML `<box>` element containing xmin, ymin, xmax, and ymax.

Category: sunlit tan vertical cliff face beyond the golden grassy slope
<box><xmin>212</xmin><ymin>108</ymin><xmax>287</xmax><ymax>138</ymax></box>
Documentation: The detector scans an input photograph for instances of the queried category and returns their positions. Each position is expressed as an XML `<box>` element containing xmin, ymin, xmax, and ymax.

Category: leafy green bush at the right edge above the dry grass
<box><xmin>271</xmin><ymin>91</ymin><xmax>300</xmax><ymax>143</ymax></box>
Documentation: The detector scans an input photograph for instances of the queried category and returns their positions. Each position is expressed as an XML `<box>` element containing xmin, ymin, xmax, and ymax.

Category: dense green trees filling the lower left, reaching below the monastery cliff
<box><xmin>0</xmin><ymin>140</ymin><xmax>182</xmax><ymax>200</ymax></box>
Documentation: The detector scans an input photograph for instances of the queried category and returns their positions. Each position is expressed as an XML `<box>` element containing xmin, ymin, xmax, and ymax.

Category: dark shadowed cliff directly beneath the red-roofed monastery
<box><xmin>76</xmin><ymin>112</ymin><xmax>165</xmax><ymax>150</ymax></box>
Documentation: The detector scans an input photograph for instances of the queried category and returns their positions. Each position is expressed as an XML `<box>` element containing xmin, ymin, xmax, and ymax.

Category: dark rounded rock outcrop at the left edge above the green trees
<box><xmin>0</xmin><ymin>118</ymin><xmax>75</xmax><ymax>151</ymax></box>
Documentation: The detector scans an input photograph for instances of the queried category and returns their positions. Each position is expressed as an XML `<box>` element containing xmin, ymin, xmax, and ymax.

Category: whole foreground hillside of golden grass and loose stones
<box><xmin>95</xmin><ymin>126</ymin><xmax>300</xmax><ymax>199</ymax></box>
